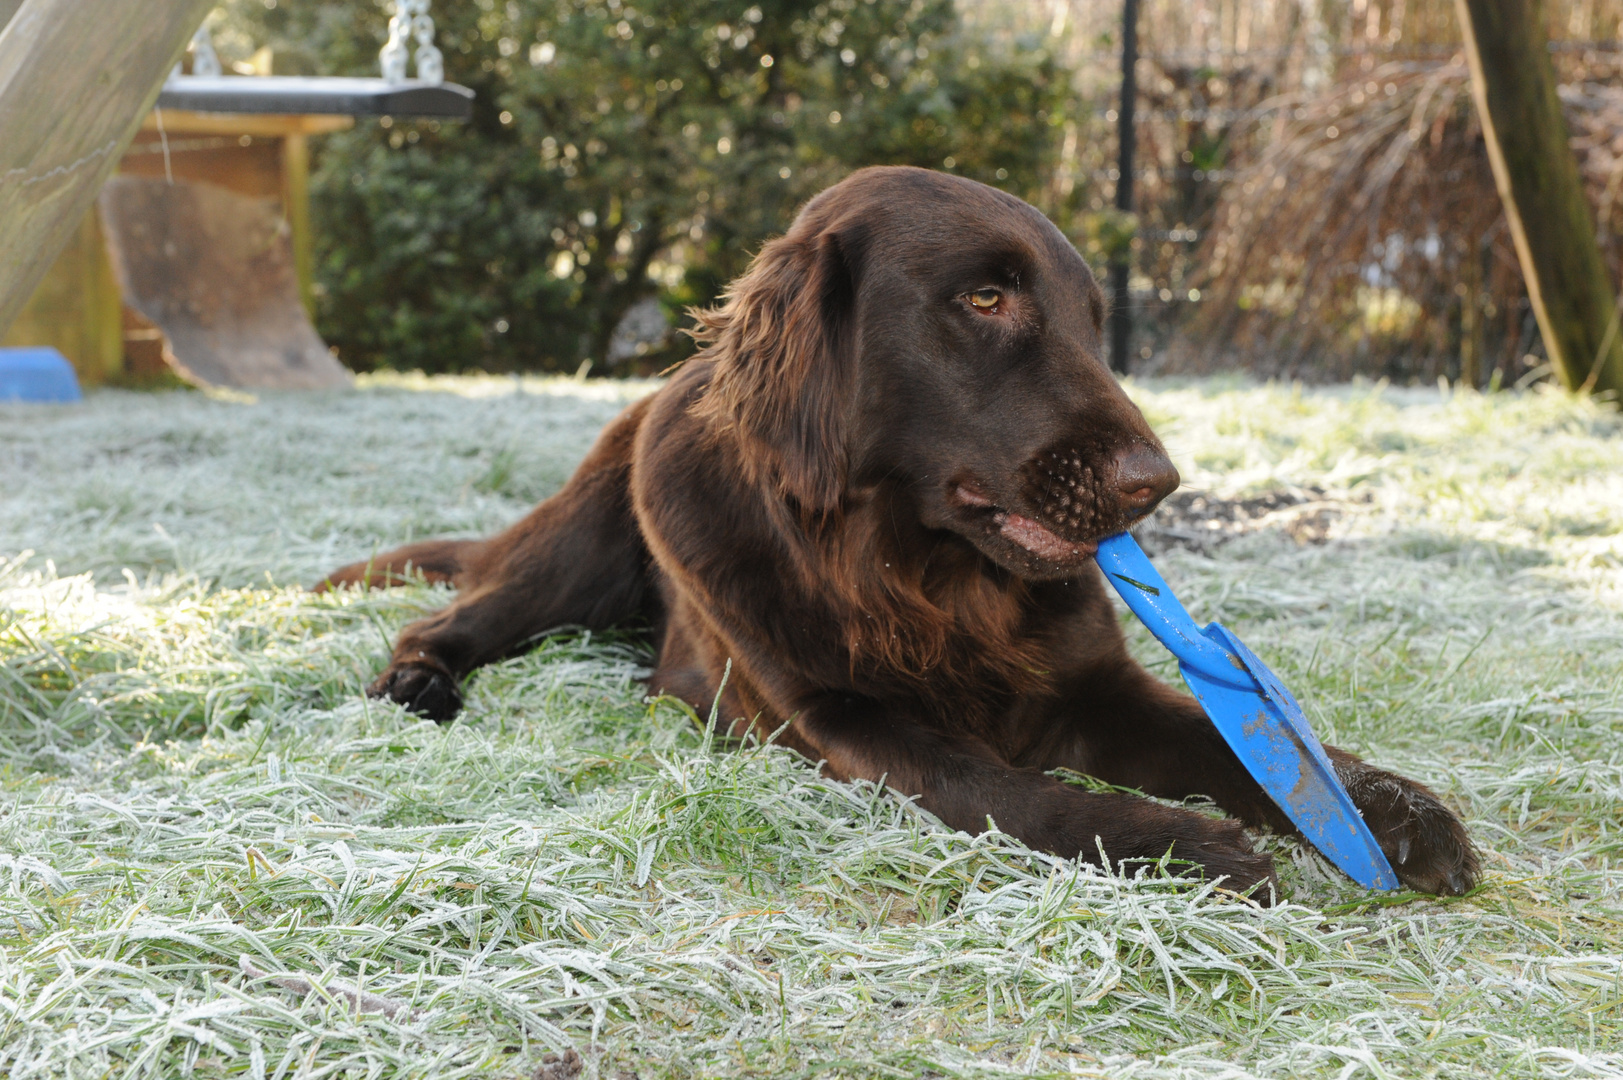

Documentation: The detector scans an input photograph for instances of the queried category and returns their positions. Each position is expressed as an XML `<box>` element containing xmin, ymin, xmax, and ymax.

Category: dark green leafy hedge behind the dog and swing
<box><xmin>216</xmin><ymin>0</ymin><xmax>1071</xmax><ymax>372</ymax></box>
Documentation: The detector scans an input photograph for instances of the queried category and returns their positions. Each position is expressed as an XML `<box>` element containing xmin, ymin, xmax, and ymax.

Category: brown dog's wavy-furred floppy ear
<box><xmin>693</xmin><ymin>231</ymin><xmax>855</xmax><ymax>513</ymax></box>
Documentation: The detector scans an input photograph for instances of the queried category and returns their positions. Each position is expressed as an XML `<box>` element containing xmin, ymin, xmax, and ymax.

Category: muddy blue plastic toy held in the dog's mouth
<box><xmin>1096</xmin><ymin>533</ymin><xmax>1397</xmax><ymax>888</ymax></box>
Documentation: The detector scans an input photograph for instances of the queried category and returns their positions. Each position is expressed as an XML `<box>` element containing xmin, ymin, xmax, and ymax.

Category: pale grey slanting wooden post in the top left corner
<box><xmin>0</xmin><ymin>0</ymin><xmax>214</xmax><ymax>333</ymax></box>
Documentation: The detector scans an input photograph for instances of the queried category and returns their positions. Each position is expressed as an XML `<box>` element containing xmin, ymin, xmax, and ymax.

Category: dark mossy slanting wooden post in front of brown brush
<box><xmin>1454</xmin><ymin>0</ymin><xmax>1623</xmax><ymax>393</ymax></box>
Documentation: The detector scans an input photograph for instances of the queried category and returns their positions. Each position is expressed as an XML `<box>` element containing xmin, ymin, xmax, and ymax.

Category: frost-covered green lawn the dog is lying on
<box><xmin>0</xmin><ymin>378</ymin><xmax>1623</xmax><ymax>1080</ymax></box>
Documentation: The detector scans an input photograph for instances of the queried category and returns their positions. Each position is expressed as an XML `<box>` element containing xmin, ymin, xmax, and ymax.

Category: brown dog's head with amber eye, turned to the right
<box><xmin>696</xmin><ymin>167</ymin><xmax>1178</xmax><ymax>578</ymax></box>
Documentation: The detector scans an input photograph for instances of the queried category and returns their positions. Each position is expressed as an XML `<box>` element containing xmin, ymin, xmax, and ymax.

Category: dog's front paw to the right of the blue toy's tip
<box><xmin>1336</xmin><ymin>760</ymin><xmax>1482</xmax><ymax>896</ymax></box>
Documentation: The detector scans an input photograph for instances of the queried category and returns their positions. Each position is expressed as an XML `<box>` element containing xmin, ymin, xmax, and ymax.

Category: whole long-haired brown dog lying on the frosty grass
<box><xmin>328</xmin><ymin>169</ymin><xmax>1477</xmax><ymax>893</ymax></box>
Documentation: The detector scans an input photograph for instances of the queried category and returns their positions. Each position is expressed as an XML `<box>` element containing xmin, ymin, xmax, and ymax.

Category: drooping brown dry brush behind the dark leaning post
<box><xmin>1170</xmin><ymin>55</ymin><xmax>1623</xmax><ymax>385</ymax></box>
